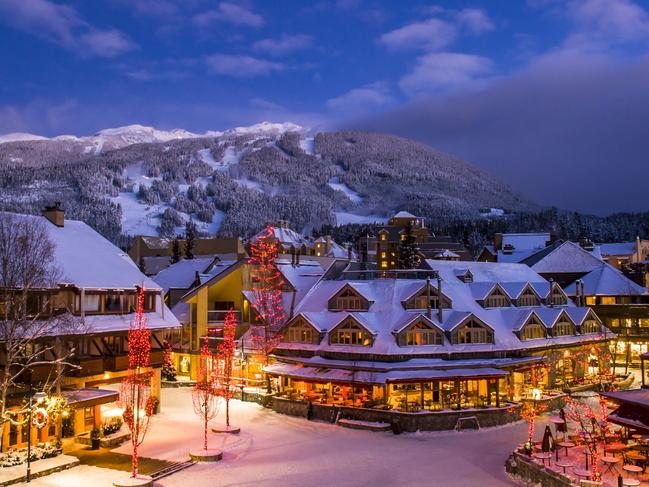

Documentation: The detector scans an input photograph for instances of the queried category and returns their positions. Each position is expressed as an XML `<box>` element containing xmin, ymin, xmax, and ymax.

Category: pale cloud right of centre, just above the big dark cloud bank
<box><xmin>399</xmin><ymin>52</ymin><xmax>492</xmax><ymax>97</ymax></box>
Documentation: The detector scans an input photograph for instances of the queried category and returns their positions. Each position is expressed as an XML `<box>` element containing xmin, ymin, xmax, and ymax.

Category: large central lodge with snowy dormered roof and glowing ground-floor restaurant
<box><xmin>266</xmin><ymin>260</ymin><xmax>608</xmax><ymax>420</ymax></box>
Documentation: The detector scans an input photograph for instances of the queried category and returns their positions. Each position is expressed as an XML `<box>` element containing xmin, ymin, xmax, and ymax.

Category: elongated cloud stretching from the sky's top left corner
<box><xmin>0</xmin><ymin>0</ymin><xmax>137</xmax><ymax>57</ymax></box>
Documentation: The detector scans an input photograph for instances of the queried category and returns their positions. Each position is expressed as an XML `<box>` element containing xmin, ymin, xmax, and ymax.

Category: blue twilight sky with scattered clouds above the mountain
<box><xmin>0</xmin><ymin>0</ymin><xmax>649</xmax><ymax>214</ymax></box>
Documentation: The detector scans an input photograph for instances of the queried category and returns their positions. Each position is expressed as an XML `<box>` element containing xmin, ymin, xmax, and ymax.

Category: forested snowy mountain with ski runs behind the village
<box><xmin>0</xmin><ymin>122</ymin><xmax>534</xmax><ymax>241</ymax></box>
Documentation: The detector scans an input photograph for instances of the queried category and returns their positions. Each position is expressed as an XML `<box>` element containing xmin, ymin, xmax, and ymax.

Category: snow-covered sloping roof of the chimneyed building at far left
<box><xmin>3</xmin><ymin>214</ymin><xmax>161</xmax><ymax>289</ymax></box>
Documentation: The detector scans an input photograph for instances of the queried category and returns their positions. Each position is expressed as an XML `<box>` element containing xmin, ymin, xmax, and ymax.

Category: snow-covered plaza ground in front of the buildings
<box><xmin>22</xmin><ymin>389</ymin><xmax>542</xmax><ymax>487</ymax></box>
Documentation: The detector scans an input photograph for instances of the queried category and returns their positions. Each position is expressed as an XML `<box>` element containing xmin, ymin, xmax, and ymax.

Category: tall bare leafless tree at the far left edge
<box><xmin>0</xmin><ymin>212</ymin><xmax>82</xmax><ymax>450</ymax></box>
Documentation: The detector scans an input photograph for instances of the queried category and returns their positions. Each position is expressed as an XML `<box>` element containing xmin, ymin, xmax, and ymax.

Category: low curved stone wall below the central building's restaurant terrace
<box><xmin>271</xmin><ymin>397</ymin><xmax>521</xmax><ymax>432</ymax></box>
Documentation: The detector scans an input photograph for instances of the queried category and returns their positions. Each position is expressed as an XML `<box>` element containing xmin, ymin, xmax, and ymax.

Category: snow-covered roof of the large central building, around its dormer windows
<box><xmin>280</xmin><ymin>260</ymin><xmax>598</xmax><ymax>355</ymax></box>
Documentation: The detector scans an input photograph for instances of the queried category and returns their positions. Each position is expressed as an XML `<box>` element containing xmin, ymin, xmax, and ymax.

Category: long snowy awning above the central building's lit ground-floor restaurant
<box><xmin>264</xmin><ymin>363</ymin><xmax>508</xmax><ymax>384</ymax></box>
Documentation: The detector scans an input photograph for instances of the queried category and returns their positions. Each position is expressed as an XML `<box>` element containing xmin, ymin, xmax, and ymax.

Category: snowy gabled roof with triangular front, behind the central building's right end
<box><xmin>521</xmin><ymin>241</ymin><xmax>602</xmax><ymax>274</ymax></box>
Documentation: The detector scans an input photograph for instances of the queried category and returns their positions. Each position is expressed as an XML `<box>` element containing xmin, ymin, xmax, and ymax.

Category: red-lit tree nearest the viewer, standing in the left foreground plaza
<box><xmin>119</xmin><ymin>287</ymin><xmax>157</xmax><ymax>478</ymax></box>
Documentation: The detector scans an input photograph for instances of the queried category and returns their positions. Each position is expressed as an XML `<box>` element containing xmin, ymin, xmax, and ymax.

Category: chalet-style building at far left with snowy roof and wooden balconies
<box><xmin>0</xmin><ymin>207</ymin><xmax>180</xmax><ymax>450</ymax></box>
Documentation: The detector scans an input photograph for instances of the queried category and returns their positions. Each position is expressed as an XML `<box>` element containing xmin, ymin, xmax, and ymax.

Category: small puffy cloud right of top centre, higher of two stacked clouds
<box><xmin>379</xmin><ymin>18</ymin><xmax>457</xmax><ymax>51</ymax></box>
